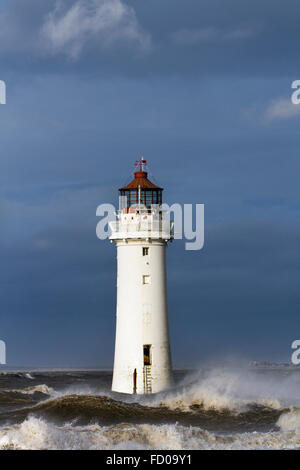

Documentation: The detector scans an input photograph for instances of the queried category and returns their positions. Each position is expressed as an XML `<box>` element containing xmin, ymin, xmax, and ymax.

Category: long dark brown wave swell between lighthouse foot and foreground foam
<box><xmin>2</xmin><ymin>395</ymin><xmax>289</xmax><ymax>432</ymax></box>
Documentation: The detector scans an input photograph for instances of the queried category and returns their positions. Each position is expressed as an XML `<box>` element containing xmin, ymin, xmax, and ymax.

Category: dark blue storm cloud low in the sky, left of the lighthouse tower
<box><xmin>0</xmin><ymin>206</ymin><xmax>115</xmax><ymax>367</ymax></box>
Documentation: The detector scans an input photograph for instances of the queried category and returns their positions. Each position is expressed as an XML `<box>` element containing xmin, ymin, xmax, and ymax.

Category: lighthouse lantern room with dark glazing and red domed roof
<box><xmin>119</xmin><ymin>158</ymin><xmax>163</xmax><ymax>209</ymax></box>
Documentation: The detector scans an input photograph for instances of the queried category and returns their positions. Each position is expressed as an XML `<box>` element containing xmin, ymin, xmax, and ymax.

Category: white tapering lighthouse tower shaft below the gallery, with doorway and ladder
<box><xmin>112</xmin><ymin>241</ymin><xmax>173</xmax><ymax>394</ymax></box>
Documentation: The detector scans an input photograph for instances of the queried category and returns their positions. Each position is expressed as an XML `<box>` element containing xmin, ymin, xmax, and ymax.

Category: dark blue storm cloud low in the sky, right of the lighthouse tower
<box><xmin>168</xmin><ymin>221</ymin><xmax>300</xmax><ymax>366</ymax></box>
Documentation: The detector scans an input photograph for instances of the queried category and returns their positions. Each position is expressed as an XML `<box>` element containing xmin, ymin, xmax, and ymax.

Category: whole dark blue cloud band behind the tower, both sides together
<box><xmin>1</xmin><ymin>209</ymin><xmax>300</xmax><ymax>366</ymax></box>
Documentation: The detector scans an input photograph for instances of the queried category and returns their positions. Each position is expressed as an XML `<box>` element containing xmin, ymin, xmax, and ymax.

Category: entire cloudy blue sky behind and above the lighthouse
<box><xmin>0</xmin><ymin>0</ymin><xmax>300</xmax><ymax>367</ymax></box>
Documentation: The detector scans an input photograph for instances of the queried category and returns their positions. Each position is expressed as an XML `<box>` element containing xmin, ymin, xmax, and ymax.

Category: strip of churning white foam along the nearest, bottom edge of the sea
<box><xmin>0</xmin><ymin>417</ymin><xmax>300</xmax><ymax>450</ymax></box>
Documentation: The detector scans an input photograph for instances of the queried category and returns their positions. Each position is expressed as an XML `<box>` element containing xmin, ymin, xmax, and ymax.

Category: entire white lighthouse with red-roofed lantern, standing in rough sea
<box><xmin>110</xmin><ymin>158</ymin><xmax>172</xmax><ymax>394</ymax></box>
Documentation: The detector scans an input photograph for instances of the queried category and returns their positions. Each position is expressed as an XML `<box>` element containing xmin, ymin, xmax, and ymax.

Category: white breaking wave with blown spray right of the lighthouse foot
<box><xmin>146</xmin><ymin>368</ymin><xmax>300</xmax><ymax>413</ymax></box>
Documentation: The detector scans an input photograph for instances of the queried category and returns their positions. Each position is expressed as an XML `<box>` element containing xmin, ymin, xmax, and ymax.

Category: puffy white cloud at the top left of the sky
<box><xmin>41</xmin><ymin>0</ymin><xmax>151</xmax><ymax>60</ymax></box>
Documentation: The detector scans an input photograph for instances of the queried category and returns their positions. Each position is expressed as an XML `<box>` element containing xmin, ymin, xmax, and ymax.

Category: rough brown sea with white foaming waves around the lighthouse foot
<box><xmin>0</xmin><ymin>367</ymin><xmax>300</xmax><ymax>450</ymax></box>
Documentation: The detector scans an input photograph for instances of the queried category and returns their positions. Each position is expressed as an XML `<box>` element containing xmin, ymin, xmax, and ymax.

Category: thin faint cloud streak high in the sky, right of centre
<box><xmin>171</xmin><ymin>26</ymin><xmax>258</xmax><ymax>45</ymax></box>
